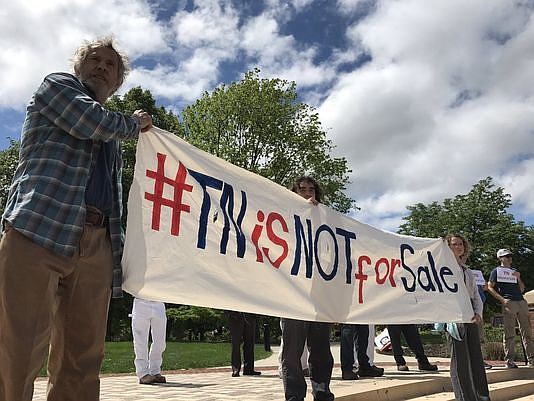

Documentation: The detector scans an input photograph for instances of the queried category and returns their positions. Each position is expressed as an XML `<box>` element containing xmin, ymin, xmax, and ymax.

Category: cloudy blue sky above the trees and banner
<box><xmin>0</xmin><ymin>0</ymin><xmax>534</xmax><ymax>231</ymax></box>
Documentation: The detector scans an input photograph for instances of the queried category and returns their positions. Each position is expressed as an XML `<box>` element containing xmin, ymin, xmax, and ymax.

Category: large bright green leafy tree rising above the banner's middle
<box><xmin>182</xmin><ymin>69</ymin><xmax>352</xmax><ymax>212</ymax></box>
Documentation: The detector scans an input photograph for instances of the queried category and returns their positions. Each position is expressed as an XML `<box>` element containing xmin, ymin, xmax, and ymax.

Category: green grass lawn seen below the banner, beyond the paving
<box><xmin>39</xmin><ymin>342</ymin><xmax>271</xmax><ymax>376</ymax></box>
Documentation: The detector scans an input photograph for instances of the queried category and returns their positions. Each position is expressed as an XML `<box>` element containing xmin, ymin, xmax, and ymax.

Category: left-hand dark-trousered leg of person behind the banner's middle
<box><xmin>282</xmin><ymin>318</ymin><xmax>309</xmax><ymax>401</ymax></box>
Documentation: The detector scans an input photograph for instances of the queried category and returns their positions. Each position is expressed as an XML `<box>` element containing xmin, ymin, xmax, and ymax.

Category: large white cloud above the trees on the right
<box><xmin>319</xmin><ymin>0</ymin><xmax>534</xmax><ymax>229</ymax></box>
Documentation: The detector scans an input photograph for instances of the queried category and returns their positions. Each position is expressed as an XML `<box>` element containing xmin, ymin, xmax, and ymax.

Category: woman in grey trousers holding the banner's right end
<box><xmin>445</xmin><ymin>234</ymin><xmax>490</xmax><ymax>401</ymax></box>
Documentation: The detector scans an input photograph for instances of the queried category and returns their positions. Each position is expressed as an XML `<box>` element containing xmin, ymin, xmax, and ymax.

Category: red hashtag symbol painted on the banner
<box><xmin>145</xmin><ymin>153</ymin><xmax>193</xmax><ymax>236</ymax></box>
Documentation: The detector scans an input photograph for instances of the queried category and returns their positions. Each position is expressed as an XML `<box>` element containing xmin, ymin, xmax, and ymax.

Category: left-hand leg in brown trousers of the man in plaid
<box><xmin>0</xmin><ymin>226</ymin><xmax>62</xmax><ymax>401</ymax></box>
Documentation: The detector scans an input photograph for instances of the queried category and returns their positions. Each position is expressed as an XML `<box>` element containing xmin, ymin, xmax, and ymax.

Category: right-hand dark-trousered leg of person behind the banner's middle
<box><xmin>307</xmin><ymin>322</ymin><xmax>334</xmax><ymax>401</ymax></box>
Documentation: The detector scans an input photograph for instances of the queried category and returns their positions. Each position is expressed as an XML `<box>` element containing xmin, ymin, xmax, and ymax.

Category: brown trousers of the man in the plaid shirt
<box><xmin>0</xmin><ymin>225</ymin><xmax>113</xmax><ymax>401</ymax></box>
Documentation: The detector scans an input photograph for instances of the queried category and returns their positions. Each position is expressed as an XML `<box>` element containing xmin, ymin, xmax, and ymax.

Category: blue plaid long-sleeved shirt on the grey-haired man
<box><xmin>2</xmin><ymin>73</ymin><xmax>139</xmax><ymax>296</ymax></box>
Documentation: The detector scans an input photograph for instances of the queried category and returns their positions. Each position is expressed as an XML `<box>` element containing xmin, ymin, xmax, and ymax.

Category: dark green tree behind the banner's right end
<box><xmin>399</xmin><ymin>177</ymin><xmax>534</xmax><ymax>310</ymax></box>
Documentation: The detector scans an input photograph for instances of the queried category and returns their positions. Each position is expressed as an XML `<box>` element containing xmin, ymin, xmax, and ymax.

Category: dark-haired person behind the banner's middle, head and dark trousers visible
<box><xmin>281</xmin><ymin>176</ymin><xmax>334</xmax><ymax>401</ymax></box>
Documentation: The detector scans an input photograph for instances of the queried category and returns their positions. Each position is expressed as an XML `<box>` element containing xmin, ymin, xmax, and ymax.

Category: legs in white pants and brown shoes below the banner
<box><xmin>132</xmin><ymin>298</ymin><xmax>167</xmax><ymax>384</ymax></box>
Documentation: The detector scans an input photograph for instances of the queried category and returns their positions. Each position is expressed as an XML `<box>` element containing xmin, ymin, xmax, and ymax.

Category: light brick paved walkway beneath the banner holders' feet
<box><xmin>33</xmin><ymin>344</ymin><xmax>449</xmax><ymax>401</ymax></box>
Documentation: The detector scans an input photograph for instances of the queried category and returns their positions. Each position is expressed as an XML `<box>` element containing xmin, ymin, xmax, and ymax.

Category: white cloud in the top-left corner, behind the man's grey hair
<box><xmin>0</xmin><ymin>0</ymin><xmax>167</xmax><ymax>108</ymax></box>
